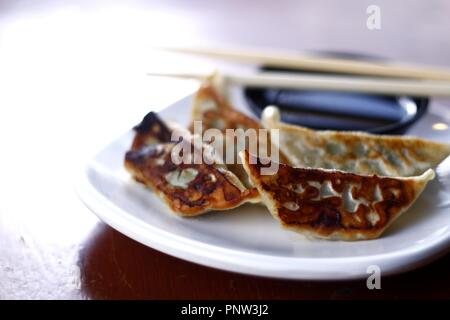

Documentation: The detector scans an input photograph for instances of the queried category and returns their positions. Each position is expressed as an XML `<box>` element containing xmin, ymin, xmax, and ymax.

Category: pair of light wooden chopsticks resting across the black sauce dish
<box><xmin>148</xmin><ymin>48</ymin><xmax>450</xmax><ymax>96</ymax></box>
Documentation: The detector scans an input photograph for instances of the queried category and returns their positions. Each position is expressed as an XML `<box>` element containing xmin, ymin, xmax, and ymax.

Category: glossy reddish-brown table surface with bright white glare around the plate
<box><xmin>0</xmin><ymin>0</ymin><xmax>450</xmax><ymax>299</ymax></box>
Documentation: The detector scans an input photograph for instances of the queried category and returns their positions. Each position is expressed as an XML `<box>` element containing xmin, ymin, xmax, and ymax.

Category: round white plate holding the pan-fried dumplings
<box><xmin>77</xmin><ymin>97</ymin><xmax>450</xmax><ymax>280</ymax></box>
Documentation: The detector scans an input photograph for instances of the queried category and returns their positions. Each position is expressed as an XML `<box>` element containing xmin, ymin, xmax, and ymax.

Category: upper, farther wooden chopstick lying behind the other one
<box><xmin>158</xmin><ymin>47</ymin><xmax>450</xmax><ymax>80</ymax></box>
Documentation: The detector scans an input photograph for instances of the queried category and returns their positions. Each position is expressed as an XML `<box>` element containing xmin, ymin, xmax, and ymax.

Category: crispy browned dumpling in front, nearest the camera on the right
<box><xmin>241</xmin><ymin>151</ymin><xmax>434</xmax><ymax>240</ymax></box>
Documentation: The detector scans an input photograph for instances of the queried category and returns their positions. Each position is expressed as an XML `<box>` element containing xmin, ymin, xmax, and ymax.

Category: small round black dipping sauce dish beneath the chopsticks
<box><xmin>244</xmin><ymin>53</ymin><xmax>429</xmax><ymax>134</ymax></box>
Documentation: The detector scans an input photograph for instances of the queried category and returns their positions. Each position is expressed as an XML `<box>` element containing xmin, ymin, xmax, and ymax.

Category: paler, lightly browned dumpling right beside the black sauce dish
<box><xmin>262</xmin><ymin>107</ymin><xmax>450</xmax><ymax>177</ymax></box>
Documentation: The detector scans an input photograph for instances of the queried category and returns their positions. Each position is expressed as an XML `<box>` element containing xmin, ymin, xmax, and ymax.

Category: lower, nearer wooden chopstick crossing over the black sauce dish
<box><xmin>148</xmin><ymin>72</ymin><xmax>450</xmax><ymax>97</ymax></box>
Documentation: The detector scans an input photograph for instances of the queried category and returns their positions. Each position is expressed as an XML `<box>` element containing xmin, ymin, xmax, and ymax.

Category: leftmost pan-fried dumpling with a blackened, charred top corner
<box><xmin>125</xmin><ymin>112</ymin><xmax>259</xmax><ymax>216</ymax></box>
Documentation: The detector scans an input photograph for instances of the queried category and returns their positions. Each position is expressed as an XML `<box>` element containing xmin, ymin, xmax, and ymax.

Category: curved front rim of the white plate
<box><xmin>75</xmin><ymin>168</ymin><xmax>450</xmax><ymax>280</ymax></box>
